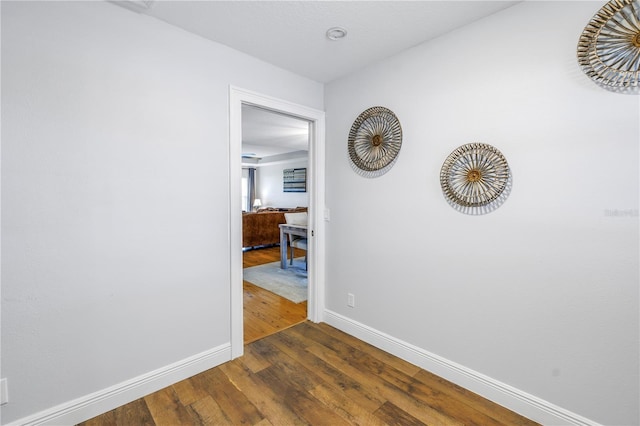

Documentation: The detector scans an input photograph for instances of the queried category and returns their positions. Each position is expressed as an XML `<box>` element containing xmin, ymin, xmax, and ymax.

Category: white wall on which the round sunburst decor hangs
<box><xmin>325</xmin><ymin>1</ymin><xmax>640</xmax><ymax>425</ymax></box>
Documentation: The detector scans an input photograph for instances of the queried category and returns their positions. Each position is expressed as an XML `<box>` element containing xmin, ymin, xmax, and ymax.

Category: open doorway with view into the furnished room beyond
<box><xmin>241</xmin><ymin>104</ymin><xmax>311</xmax><ymax>344</ymax></box>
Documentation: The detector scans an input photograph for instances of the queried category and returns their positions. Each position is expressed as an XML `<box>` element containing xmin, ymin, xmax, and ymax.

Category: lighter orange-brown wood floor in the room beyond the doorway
<box><xmin>242</xmin><ymin>247</ymin><xmax>307</xmax><ymax>344</ymax></box>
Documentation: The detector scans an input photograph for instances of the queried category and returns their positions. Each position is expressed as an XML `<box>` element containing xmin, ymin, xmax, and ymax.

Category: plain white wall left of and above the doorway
<box><xmin>2</xmin><ymin>1</ymin><xmax>323</xmax><ymax>423</ymax></box>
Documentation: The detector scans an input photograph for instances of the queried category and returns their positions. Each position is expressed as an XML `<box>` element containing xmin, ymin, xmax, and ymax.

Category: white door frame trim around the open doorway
<box><xmin>229</xmin><ymin>86</ymin><xmax>325</xmax><ymax>359</ymax></box>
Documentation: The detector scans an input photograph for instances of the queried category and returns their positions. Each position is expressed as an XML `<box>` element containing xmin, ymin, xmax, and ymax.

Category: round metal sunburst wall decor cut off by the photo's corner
<box><xmin>578</xmin><ymin>0</ymin><xmax>640</xmax><ymax>93</ymax></box>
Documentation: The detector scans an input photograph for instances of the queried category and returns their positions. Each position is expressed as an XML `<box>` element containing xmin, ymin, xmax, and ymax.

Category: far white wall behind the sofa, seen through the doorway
<box><xmin>257</xmin><ymin>160</ymin><xmax>309</xmax><ymax>207</ymax></box>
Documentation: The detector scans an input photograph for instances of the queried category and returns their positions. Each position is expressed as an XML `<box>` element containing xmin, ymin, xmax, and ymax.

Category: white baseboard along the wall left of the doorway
<box><xmin>10</xmin><ymin>343</ymin><xmax>231</xmax><ymax>426</ymax></box>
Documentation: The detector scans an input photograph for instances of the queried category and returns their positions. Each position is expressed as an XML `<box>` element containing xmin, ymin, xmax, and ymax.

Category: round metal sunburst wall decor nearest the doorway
<box><xmin>348</xmin><ymin>106</ymin><xmax>402</xmax><ymax>177</ymax></box>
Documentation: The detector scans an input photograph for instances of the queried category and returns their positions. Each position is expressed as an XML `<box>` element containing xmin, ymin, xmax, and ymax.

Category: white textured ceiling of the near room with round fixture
<box><xmin>127</xmin><ymin>0</ymin><xmax>517</xmax><ymax>83</ymax></box>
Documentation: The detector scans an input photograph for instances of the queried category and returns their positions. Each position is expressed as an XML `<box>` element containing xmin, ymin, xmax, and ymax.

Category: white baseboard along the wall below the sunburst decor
<box><xmin>324</xmin><ymin>310</ymin><xmax>599</xmax><ymax>426</ymax></box>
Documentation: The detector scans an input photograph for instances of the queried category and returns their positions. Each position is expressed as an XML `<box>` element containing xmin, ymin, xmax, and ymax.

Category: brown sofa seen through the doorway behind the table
<box><xmin>242</xmin><ymin>207</ymin><xmax>307</xmax><ymax>247</ymax></box>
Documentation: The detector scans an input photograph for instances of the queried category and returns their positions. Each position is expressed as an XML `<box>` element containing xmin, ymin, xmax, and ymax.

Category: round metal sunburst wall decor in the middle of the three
<box><xmin>440</xmin><ymin>143</ymin><xmax>512</xmax><ymax>214</ymax></box>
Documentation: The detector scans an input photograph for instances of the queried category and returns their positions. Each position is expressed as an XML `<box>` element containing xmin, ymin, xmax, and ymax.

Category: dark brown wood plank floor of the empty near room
<box><xmin>81</xmin><ymin>322</ymin><xmax>536</xmax><ymax>426</ymax></box>
